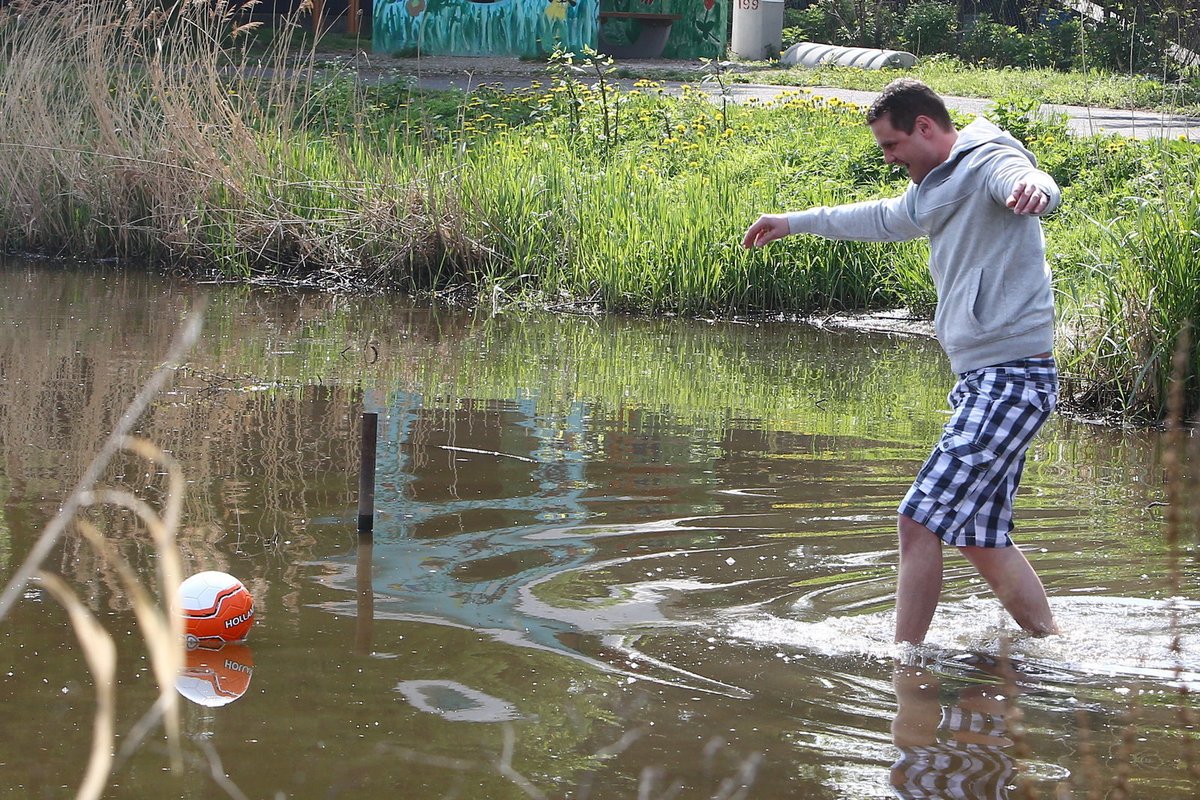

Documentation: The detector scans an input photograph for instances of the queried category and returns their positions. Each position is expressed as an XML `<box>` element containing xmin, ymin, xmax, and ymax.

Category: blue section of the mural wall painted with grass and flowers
<box><xmin>371</xmin><ymin>0</ymin><xmax>599</xmax><ymax>58</ymax></box>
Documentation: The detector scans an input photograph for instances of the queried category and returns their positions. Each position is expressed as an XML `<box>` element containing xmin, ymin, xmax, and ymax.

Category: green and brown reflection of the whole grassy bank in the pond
<box><xmin>0</xmin><ymin>270</ymin><xmax>1153</xmax><ymax>561</ymax></box>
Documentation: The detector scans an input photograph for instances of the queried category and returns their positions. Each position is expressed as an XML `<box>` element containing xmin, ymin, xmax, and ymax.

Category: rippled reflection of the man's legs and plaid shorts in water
<box><xmin>890</xmin><ymin>664</ymin><xmax>1018</xmax><ymax>800</ymax></box>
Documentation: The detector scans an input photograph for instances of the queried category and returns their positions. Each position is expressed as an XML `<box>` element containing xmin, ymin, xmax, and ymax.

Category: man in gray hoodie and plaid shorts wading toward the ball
<box><xmin>742</xmin><ymin>78</ymin><xmax>1061</xmax><ymax>644</ymax></box>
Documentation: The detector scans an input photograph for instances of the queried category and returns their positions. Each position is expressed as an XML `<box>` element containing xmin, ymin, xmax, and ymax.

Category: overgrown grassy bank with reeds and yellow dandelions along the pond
<box><xmin>0</xmin><ymin>0</ymin><xmax>1200</xmax><ymax>416</ymax></box>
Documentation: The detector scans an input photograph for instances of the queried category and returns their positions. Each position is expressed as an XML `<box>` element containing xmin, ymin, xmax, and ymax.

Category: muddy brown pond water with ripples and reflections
<box><xmin>0</xmin><ymin>263</ymin><xmax>1200</xmax><ymax>799</ymax></box>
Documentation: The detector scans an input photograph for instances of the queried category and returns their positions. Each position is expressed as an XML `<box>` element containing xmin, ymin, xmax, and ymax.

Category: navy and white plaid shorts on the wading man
<box><xmin>899</xmin><ymin>357</ymin><xmax>1058</xmax><ymax>547</ymax></box>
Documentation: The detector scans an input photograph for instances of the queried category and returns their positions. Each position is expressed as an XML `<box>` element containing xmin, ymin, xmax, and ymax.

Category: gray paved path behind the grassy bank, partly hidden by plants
<box><xmin>403</xmin><ymin>72</ymin><xmax>1200</xmax><ymax>142</ymax></box>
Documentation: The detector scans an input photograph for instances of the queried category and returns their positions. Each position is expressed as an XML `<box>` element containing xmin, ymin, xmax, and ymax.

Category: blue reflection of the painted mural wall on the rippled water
<box><xmin>352</xmin><ymin>393</ymin><xmax>592</xmax><ymax>648</ymax></box>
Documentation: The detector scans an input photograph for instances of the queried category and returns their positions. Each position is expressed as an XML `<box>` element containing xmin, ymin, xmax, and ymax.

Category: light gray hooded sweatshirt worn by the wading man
<box><xmin>787</xmin><ymin>118</ymin><xmax>1062</xmax><ymax>373</ymax></box>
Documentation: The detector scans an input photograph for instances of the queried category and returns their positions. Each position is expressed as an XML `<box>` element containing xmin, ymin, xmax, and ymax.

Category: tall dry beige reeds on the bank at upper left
<box><xmin>0</xmin><ymin>0</ymin><xmax>469</xmax><ymax>283</ymax></box>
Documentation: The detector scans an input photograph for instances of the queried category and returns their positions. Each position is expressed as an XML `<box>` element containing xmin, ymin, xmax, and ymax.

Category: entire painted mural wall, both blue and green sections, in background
<box><xmin>372</xmin><ymin>0</ymin><xmax>730</xmax><ymax>59</ymax></box>
